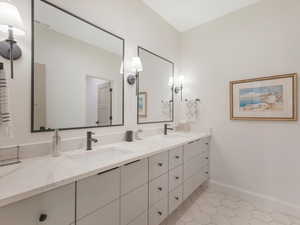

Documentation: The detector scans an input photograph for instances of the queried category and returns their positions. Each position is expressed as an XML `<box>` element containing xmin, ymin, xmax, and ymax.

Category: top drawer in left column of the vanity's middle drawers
<box><xmin>149</xmin><ymin>152</ymin><xmax>169</xmax><ymax>180</ymax></box>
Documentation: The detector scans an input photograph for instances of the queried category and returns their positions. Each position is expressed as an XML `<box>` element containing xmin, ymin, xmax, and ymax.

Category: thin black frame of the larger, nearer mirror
<box><xmin>31</xmin><ymin>0</ymin><xmax>125</xmax><ymax>133</ymax></box>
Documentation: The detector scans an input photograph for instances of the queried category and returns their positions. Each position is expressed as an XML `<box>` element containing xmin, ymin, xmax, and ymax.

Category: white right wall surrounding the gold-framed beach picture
<box><xmin>181</xmin><ymin>0</ymin><xmax>300</xmax><ymax>207</ymax></box>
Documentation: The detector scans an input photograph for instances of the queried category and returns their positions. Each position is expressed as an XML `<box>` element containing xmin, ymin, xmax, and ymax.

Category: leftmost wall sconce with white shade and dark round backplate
<box><xmin>0</xmin><ymin>2</ymin><xmax>25</xmax><ymax>79</ymax></box>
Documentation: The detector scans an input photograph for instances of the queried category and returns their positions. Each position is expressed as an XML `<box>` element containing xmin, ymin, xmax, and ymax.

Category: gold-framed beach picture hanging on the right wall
<box><xmin>230</xmin><ymin>74</ymin><xmax>297</xmax><ymax>121</ymax></box>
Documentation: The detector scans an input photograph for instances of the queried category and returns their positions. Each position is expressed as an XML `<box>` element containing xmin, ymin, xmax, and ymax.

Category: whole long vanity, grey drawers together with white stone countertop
<box><xmin>0</xmin><ymin>133</ymin><xmax>210</xmax><ymax>225</ymax></box>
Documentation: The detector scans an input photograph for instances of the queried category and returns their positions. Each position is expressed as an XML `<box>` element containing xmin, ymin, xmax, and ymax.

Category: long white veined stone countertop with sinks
<box><xmin>0</xmin><ymin>133</ymin><xmax>210</xmax><ymax>207</ymax></box>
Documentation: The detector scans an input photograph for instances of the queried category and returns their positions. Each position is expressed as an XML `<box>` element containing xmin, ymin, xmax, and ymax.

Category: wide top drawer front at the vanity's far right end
<box><xmin>184</xmin><ymin>138</ymin><xmax>209</xmax><ymax>162</ymax></box>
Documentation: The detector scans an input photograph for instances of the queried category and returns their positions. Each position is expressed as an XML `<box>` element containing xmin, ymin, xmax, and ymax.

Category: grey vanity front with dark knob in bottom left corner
<box><xmin>0</xmin><ymin>184</ymin><xmax>75</xmax><ymax>225</ymax></box>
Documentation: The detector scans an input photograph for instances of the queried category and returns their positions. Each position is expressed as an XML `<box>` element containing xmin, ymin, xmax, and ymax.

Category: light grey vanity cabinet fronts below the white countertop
<box><xmin>0</xmin><ymin>134</ymin><xmax>209</xmax><ymax>225</ymax></box>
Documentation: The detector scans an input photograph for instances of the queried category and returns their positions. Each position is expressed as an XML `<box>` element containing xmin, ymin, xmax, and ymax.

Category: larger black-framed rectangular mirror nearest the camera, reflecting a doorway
<box><xmin>31</xmin><ymin>0</ymin><xmax>124</xmax><ymax>132</ymax></box>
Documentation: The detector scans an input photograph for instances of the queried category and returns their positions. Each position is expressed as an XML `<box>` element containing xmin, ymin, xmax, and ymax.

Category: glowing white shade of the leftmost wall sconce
<box><xmin>0</xmin><ymin>2</ymin><xmax>25</xmax><ymax>35</ymax></box>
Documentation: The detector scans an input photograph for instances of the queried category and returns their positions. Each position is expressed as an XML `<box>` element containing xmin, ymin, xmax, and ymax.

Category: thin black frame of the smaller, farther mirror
<box><xmin>136</xmin><ymin>46</ymin><xmax>175</xmax><ymax>124</ymax></box>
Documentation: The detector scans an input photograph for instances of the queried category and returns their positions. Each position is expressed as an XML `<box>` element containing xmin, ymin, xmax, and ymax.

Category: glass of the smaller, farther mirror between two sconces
<box><xmin>137</xmin><ymin>47</ymin><xmax>174</xmax><ymax>124</ymax></box>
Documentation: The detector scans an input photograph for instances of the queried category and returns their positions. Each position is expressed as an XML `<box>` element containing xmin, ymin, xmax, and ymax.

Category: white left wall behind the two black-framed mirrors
<box><xmin>0</xmin><ymin>0</ymin><xmax>179</xmax><ymax>146</ymax></box>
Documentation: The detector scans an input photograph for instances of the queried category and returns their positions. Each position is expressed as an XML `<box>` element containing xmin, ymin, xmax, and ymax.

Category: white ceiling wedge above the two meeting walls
<box><xmin>142</xmin><ymin>0</ymin><xmax>260</xmax><ymax>32</ymax></box>
